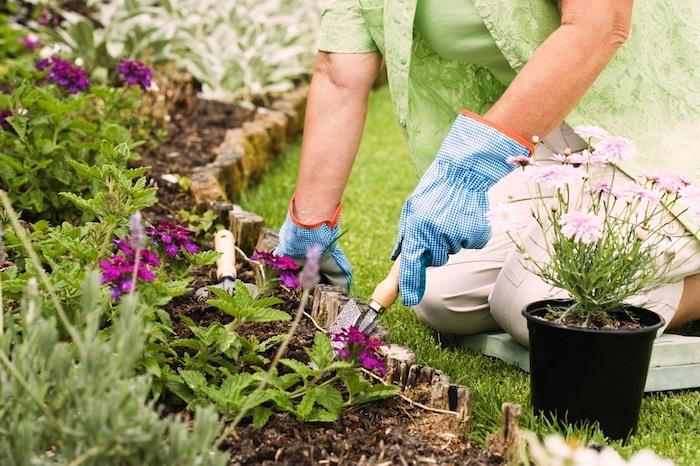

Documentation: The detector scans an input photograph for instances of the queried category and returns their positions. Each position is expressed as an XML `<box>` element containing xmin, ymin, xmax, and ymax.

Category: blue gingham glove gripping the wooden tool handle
<box><xmin>392</xmin><ymin>112</ymin><xmax>532</xmax><ymax>306</ymax></box>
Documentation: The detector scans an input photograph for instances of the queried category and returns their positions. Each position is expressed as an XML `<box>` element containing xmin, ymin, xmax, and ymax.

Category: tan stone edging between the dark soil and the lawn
<box><xmin>190</xmin><ymin>86</ymin><xmax>309</xmax><ymax>206</ymax></box>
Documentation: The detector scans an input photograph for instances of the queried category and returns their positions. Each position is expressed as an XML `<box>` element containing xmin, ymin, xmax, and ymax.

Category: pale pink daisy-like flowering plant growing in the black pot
<box><xmin>488</xmin><ymin>127</ymin><xmax>700</xmax><ymax>327</ymax></box>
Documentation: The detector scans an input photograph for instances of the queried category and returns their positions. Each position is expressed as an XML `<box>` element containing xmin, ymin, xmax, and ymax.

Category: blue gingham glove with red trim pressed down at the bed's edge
<box><xmin>275</xmin><ymin>199</ymin><xmax>352</xmax><ymax>292</ymax></box>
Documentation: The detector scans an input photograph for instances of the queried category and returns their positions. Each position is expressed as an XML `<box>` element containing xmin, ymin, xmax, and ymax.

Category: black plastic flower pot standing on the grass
<box><xmin>522</xmin><ymin>300</ymin><xmax>664</xmax><ymax>439</ymax></box>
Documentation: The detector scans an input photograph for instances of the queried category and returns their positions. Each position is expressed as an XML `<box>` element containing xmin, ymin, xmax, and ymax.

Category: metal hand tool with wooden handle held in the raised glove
<box><xmin>328</xmin><ymin>257</ymin><xmax>400</xmax><ymax>334</ymax></box>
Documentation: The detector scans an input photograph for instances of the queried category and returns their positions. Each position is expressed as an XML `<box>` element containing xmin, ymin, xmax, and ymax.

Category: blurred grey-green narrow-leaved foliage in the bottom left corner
<box><xmin>0</xmin><ymin>273</ymin><xmax>226</xmax><ymax>466</ymax></box>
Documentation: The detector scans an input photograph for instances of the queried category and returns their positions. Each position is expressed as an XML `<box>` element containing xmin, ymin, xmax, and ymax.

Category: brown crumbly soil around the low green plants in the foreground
<box><xmin>164</xmin><ymin>267</ymin><xmax>505</xmax><ymax>466</ymax></box>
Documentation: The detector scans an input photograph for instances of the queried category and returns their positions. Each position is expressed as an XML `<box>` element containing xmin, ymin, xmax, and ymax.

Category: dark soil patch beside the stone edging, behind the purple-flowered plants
<box><xmin>139</xmin><ymin>86</ymin><xmax>255</xmax><ymax>222</ymax></box>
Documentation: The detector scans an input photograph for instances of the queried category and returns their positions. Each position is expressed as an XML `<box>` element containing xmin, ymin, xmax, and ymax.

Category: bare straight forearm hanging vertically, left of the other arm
<box><xmin>295</xmin><ymin>52</ymin><xmax>381</xmax><ymax>224</ymax></box>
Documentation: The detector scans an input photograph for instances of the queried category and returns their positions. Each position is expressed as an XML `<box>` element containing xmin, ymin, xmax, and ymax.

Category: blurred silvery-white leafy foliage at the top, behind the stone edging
<box><xmin>83</xmin><ymin>0</ymin><xmax>320</xmax><ymax>101</ymax></box>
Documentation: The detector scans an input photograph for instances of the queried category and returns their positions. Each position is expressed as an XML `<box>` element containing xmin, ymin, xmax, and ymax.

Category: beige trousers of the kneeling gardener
<box><xmin>414</xmin><ymin>124</ymin><xmax>700</xmax><ymax>345</ymax></box>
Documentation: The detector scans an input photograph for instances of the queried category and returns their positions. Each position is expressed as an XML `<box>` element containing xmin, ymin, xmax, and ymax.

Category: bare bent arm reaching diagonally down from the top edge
<box><xmin>485</xmin><ymin>0</ymin><xmax>633</xmax><ymax>139</ymax></box>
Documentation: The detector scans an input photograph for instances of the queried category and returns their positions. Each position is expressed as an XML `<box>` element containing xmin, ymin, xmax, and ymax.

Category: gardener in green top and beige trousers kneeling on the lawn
<box><xmin>278</xmin><ymin>0</ymin><xmax>700</xmax><ymax>343</ymax></box>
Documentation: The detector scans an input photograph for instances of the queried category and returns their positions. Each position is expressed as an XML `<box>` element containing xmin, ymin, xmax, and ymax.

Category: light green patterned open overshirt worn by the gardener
<box><xmin>319</xmin><ymin>0</ymin><xmax>700</xmax><ymax>233</ymax></box>
